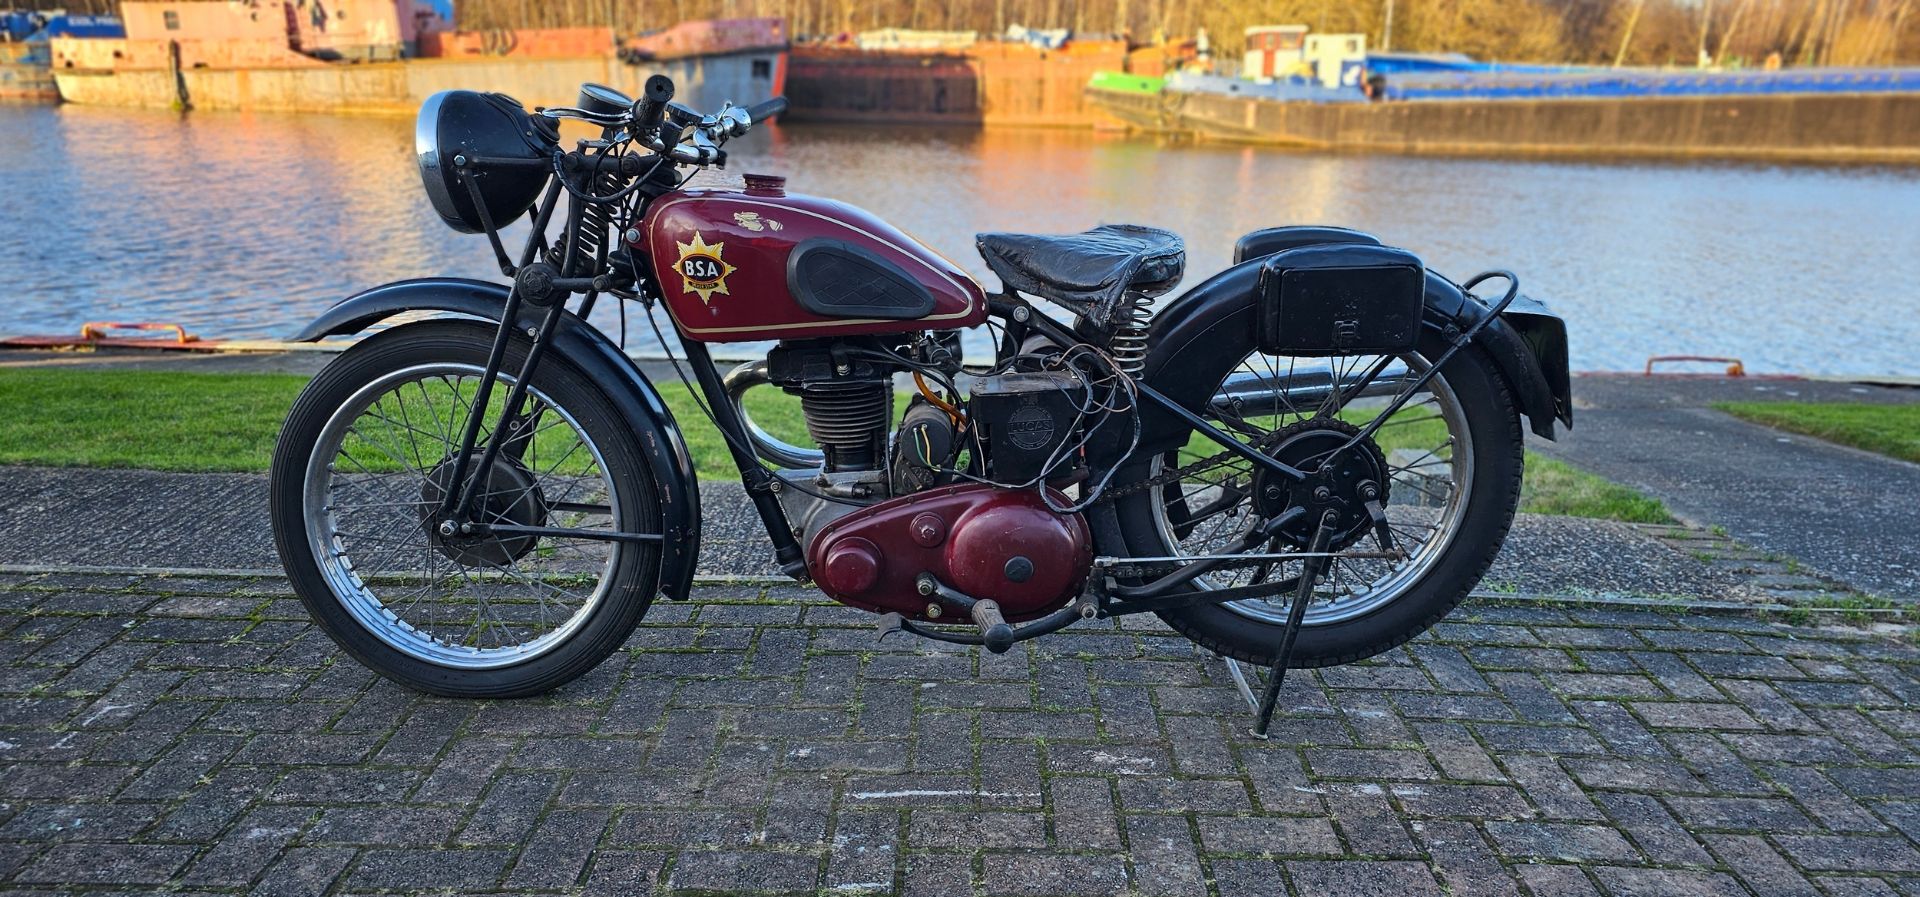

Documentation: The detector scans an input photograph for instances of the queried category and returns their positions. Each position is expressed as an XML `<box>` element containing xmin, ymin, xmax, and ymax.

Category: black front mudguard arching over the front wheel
<box><xmin>292</xmin><ymin>277</ymin><xmax>701</xmax><ymax>599</ymax></box>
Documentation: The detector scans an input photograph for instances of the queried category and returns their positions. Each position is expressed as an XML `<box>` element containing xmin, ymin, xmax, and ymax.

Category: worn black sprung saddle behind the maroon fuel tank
<box><xmin>973</xmin><ymin>225</ymin><xmax>1187</xmax><ymax>327</ymax></box>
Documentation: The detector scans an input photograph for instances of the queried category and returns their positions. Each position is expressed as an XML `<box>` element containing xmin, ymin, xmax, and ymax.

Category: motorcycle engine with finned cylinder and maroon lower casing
<box><xmin>766</xmin><ymin>334</ymin><xmax>1092</xmax><ymax>620</ymax></box>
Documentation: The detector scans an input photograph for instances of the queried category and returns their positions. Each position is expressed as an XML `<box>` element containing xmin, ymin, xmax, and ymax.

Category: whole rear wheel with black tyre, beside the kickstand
<box><xmin>1117</xmin><ymin>340</ymin><xmax>1523</xmax><ymax>667</ymax></box>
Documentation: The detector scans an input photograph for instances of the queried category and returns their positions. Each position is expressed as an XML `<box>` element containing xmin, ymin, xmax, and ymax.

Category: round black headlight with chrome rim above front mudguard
<box><xmin>413</xmin><ymin>90</ymin><xmax>557</xmax><ymax>234</ymax></box>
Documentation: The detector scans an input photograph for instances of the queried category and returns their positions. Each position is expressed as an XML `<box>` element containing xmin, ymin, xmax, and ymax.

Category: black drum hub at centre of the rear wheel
<box><xmin>1254</xmin><ymin>417</ymin><xmax>1390</xmax><ymax>551</ymax></box>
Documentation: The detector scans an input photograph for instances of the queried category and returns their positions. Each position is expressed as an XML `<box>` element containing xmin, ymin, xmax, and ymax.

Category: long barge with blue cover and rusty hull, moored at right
<box><xmin>1087</xmin><ymin>42</ymin><xmax>1920</xmax><ymax>165</ymax></box>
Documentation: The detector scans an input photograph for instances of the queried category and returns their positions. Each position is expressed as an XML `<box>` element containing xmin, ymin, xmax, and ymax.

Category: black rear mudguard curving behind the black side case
<box><xmin>1135</xmin><ymin>259</ymin><xmax>1572</xmax><ymax>457</ymax></box>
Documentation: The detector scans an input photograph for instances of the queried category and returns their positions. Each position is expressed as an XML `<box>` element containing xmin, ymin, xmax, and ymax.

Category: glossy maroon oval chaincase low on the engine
<box><xmin>806</xmin><ymin>484</ymin><xmax>1092</xmax><ymax>622</ymax></box>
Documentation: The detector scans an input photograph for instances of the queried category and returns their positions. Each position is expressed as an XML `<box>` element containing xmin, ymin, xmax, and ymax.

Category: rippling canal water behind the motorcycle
<box><xmin>0</xmin><ymin>106</ymin><xmax>1920</xmax><ymax>375</ymax></box>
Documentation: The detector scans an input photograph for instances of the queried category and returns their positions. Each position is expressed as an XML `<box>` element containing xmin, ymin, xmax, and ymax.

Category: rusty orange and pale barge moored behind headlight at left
<box><xmin>52</xmin><ymin>0</ymin><xmax>787</xmax><ymax>115</ymax></box>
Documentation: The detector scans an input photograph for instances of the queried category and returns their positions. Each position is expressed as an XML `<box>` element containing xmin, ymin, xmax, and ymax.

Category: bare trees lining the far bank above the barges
<box><xmin>18</xmin><ymin>0</ymin><xmax>1920</xmax><ymax>67</ymax></box>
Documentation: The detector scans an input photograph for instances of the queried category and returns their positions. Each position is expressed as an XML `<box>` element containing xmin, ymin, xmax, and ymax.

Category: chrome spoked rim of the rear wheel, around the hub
<box><xmin>1150</xmin><ymin>352</ymin><xmax>1473</xmax><ymax>626</ymax></box>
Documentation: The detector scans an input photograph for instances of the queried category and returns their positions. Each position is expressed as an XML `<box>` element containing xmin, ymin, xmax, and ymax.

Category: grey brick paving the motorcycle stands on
<box><xmin>0</xmin><ymin>574</ymin><xmax>1920</xmax><ymax>897</ymax></box>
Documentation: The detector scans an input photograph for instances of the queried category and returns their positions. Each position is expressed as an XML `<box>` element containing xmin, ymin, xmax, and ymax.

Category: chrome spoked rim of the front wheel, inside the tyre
<box><xmin>303</xmin><ymin>363</ymin><xmax>622</xmax><ymax>670</ymax></box>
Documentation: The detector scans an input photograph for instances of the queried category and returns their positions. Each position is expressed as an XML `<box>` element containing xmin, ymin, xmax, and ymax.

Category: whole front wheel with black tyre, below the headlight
<box><xmin>269</xmin><ymin>321</ymin><xmax>660</xmax><ymax>697</ymax></box>
